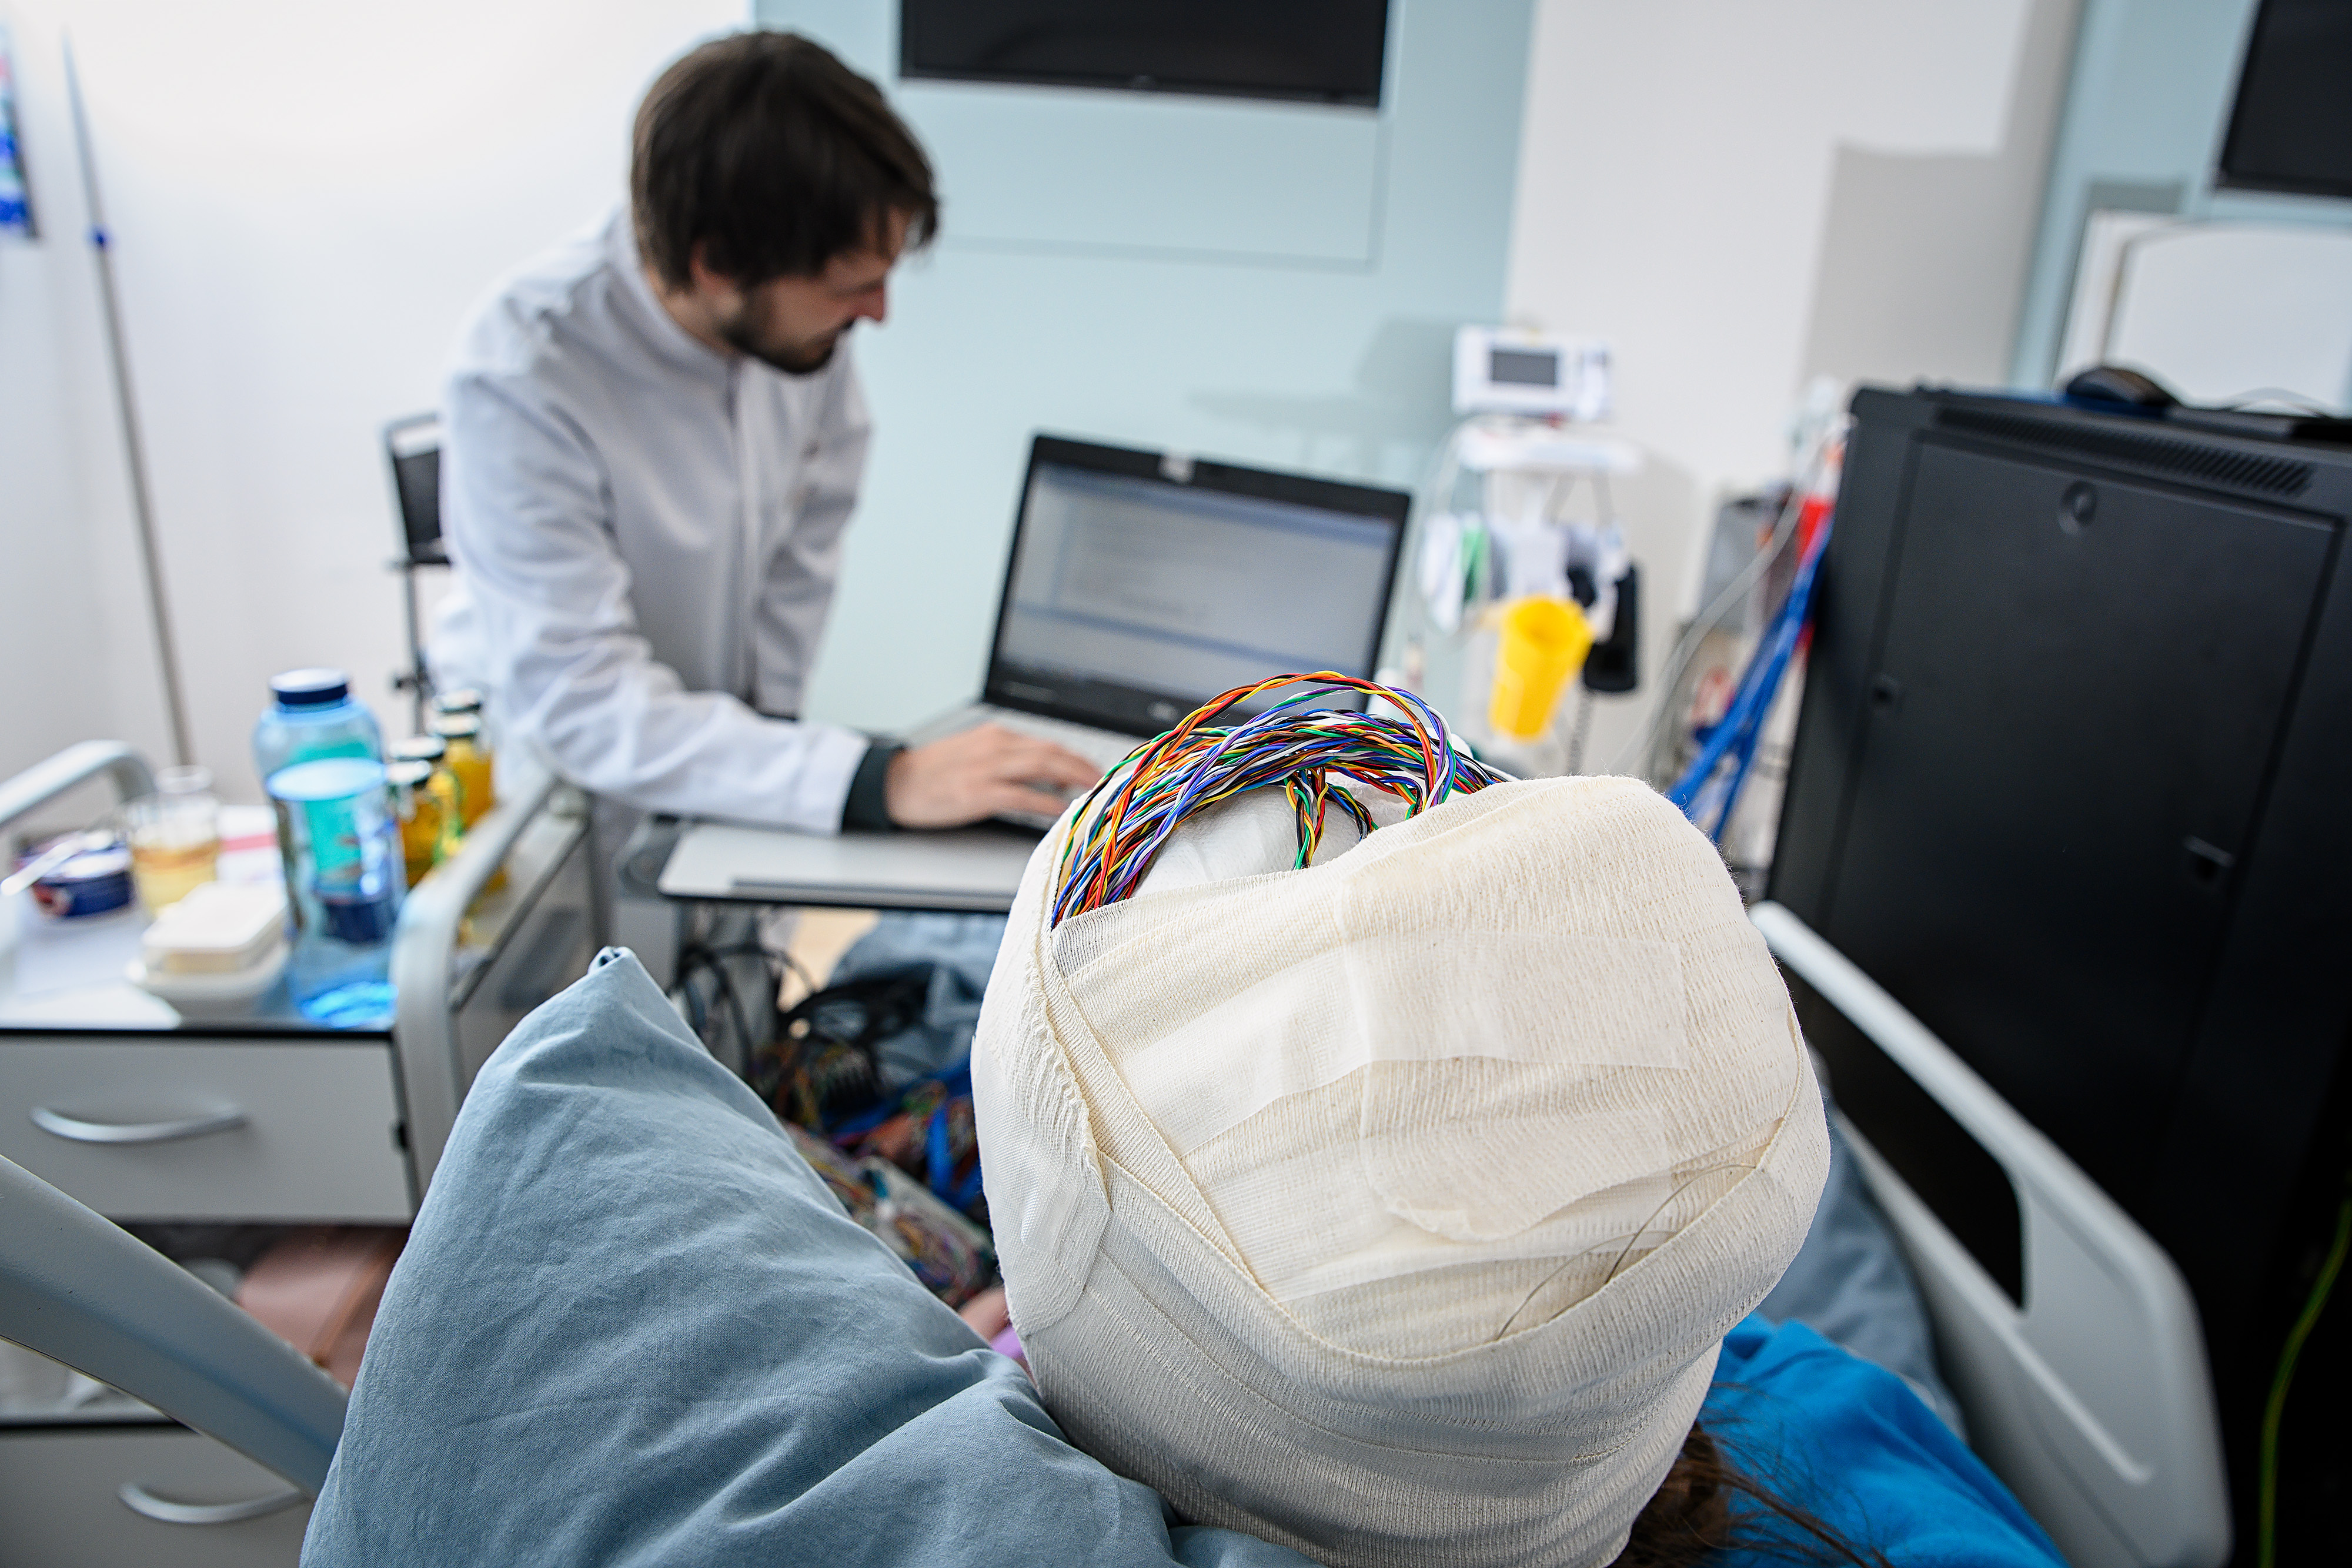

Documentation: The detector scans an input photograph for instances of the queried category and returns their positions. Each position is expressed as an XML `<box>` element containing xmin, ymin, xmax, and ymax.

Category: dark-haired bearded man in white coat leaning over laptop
<box><xmin>433</xmin><ymin>33</ymin><xmax>1096</xmax><ymax>832</ymax></box>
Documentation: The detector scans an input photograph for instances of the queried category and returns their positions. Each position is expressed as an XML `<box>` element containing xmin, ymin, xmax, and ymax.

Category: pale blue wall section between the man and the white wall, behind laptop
<box><xmin>760</xmin><ymin>0</ymin><xmax>1531</xmax><ymax>727</ymax></box>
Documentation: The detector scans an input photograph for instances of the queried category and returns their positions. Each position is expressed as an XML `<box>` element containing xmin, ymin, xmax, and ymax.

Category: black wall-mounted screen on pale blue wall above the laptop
<box><xmin>898</xmin><ymin>0</ymin><xmax>1388</xmax><ymax>108</ymax></box>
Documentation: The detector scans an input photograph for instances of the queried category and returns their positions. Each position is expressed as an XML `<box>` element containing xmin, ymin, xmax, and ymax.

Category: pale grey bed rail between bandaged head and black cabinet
<box><xmin>1750</xmin><ymin>902</ymin><xmax>2230</xmax><ymax>1568</ymax></box>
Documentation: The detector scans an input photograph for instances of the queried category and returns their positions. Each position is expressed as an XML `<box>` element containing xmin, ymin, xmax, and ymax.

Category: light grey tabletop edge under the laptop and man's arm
<box><xmin>659</xmin><ymin>823</ymin><xmax>1037</xmax><ymax>914</ymax></box>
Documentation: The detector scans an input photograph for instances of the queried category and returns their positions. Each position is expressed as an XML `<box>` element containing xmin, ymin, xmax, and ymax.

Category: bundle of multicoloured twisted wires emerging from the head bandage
<box><xmin>1051</xmin><ymin>670</ymin><xmax>1505</xmax><ymax>926</ymax></box>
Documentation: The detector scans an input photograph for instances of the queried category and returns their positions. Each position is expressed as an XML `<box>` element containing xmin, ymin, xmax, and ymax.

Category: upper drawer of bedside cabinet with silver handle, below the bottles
<box><xmin>0</xmin><ymin>1037</ymin><xmax>414</xmax><ymax>1222</ymax></box>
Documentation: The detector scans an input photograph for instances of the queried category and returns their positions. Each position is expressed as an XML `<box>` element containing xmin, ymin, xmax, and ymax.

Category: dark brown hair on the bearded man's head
<box><xmin>628</xmin><ymin>33</ymin><xmax>938</xmax><ymax>289</ymax></box>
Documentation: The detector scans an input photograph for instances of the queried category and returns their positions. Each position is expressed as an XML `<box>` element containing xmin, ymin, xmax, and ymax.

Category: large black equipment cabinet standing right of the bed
<box><xmin>1769</xmin><ymin>388</ymin><xmax>2352</xmax><ymax>1561</ymax></box>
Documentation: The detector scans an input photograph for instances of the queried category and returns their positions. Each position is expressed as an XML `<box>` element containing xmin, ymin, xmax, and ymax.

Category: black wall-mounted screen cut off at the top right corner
<box><xmin>2220</xmin><ymin>0</ymin><xmax>2352</xmax><ymax>195</ymax></box>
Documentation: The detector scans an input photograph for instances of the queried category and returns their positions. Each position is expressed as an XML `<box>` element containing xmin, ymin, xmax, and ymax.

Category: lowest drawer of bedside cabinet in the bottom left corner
<box><xmin>0</xmin><ymin>1425</ymin><xmax>310</xmax><ymax>1568</ymax></box>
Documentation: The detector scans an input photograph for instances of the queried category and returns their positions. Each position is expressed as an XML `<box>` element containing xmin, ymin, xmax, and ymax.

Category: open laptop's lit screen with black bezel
<box><xmin>983</xmin><ymin>435</ymin><xmax>1411</xmax><ymax>736</ymax></box>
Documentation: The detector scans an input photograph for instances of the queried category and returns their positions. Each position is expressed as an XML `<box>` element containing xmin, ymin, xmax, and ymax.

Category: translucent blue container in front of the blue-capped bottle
<box><xmin>266</xmin><ymin>757</ymin><xmax>407</xmax><ymax>1027</ymax></box>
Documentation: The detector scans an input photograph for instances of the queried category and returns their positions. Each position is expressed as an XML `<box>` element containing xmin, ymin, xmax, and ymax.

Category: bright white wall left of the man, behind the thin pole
<box><xmin>0</xmin><ymin>0</ymin><xmax>746</xmax><ymax>799</ymax></box>
